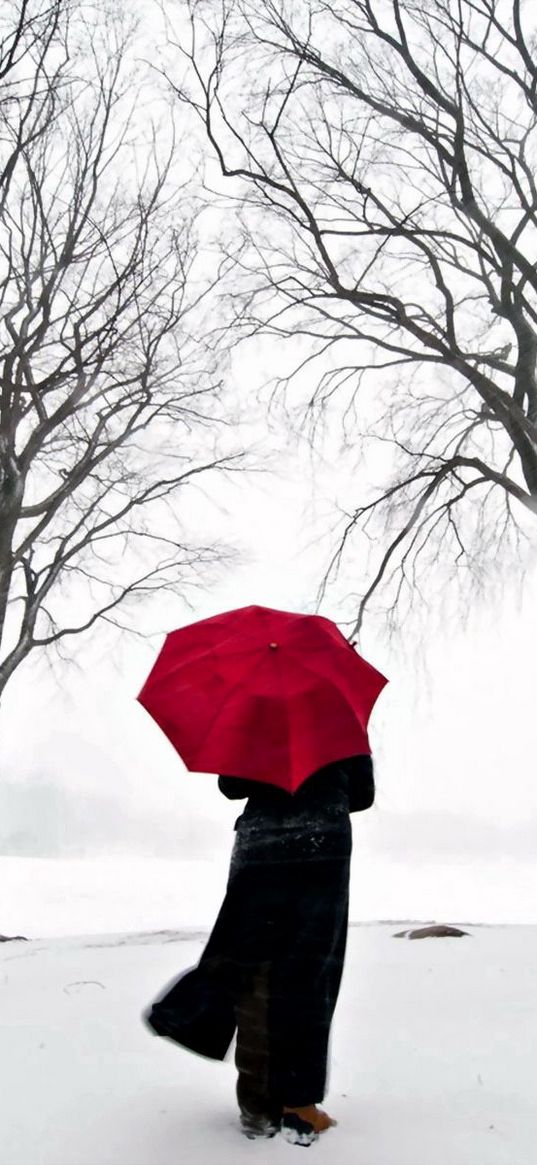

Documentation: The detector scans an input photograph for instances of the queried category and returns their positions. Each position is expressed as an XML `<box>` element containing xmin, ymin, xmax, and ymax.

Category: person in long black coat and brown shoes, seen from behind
<box><xmin>144</xmin><ymin>755</ymin><xmax>375</xmax><ymax>1145</ymax></box>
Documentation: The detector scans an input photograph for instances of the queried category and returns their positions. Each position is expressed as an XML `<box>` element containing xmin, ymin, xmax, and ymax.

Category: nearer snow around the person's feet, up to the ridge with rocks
<box><xmin>0</xmin><ymin>924</ymin><xmax>537</xmax><ymax>1165</ymax></box>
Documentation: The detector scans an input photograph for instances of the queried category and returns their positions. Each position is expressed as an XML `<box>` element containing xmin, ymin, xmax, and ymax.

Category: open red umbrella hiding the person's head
<box><xmin>137</xmin><ymin>607</ymin><xmax>387</xmax><ymax>792</ymax></box>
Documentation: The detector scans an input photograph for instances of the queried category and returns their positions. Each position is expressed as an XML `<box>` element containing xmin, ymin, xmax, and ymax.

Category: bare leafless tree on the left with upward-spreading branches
<box><xmin>0</xmin><ymin>0</ymin><xmax>240</xmax><ymax>694</ymax></box>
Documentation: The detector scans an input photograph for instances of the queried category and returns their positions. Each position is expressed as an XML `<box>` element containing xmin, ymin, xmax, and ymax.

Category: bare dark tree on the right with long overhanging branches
<box><xmin>170</xmin><ymin>0</ymin><xmax>537</xmax><ymax>631</ymax></box>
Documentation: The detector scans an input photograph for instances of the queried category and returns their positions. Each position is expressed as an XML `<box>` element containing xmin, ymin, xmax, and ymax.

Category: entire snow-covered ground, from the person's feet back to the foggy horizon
<box><xmin>0</xmin><ymin>846</ymin><xmax>537</xmax><ymax>1165</ymax></box>
